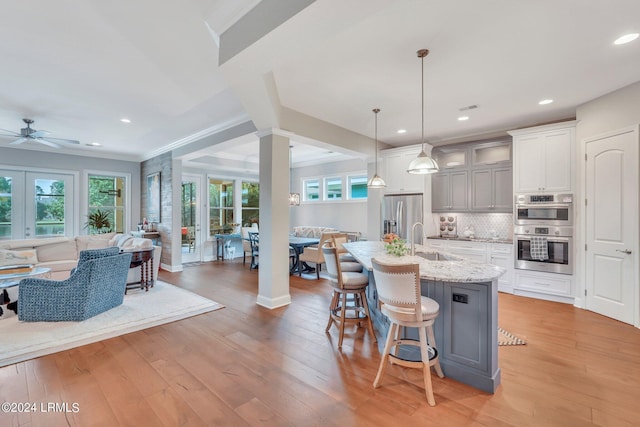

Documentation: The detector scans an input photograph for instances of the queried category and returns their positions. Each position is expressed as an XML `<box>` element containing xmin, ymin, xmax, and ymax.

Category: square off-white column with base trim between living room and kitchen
<box><xmin>257</xmin><ymin>129</ymin><xmax>291</xmax><ymax>308</ymax></box>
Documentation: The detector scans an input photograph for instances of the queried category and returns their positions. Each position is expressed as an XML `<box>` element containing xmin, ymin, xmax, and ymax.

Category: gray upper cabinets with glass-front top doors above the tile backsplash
<box><xmin>431</xmin><ymin>139</ymin><xmax>513</xmax><ymax>212</ymax></box>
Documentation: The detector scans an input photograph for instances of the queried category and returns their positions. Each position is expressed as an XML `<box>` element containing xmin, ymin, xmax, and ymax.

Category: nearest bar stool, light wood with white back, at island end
<box><xmin>371</xmin><ymin>258</ymin><xmax>444</xmax><ymax>406</ymax></box>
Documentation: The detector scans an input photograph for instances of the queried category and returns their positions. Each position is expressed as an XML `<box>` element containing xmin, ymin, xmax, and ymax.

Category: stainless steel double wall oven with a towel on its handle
<box><xmin>513</xmin><ymin>194</ymin><xmax>574</xmax><ymax>274</ymax></box>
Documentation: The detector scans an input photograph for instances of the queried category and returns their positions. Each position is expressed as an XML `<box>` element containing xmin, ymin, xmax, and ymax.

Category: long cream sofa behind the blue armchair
<box><xmin>0</xmin><ymin>233</ymin><xmax>162</xmax><ymax>282</ymax></box>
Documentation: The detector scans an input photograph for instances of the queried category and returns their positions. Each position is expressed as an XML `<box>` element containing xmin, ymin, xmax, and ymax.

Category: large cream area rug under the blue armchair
<box><xmin>0</xmin><ymin>281</ymin><xmax>224</xmax><ymax>367</ymax></box>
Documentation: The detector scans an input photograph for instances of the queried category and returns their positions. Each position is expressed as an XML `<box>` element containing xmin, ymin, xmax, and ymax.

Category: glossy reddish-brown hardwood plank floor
<box><xmin>0</xmin><ymin>260</ymin><xmax>640</xmax><ymax>427</ymax></box>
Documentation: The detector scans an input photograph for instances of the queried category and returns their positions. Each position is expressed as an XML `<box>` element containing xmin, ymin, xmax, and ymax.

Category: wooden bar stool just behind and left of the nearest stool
<box><xmin>322</xmin><ymin>243</ymin><xmax>376</xmax><ymax>348</ymax></box>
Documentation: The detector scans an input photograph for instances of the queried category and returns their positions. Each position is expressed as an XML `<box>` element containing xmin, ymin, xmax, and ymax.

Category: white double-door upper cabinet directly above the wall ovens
<box><xmin>509</xmin><ymin>121</ymin><xmax>575</xmax><ymax>193</ymax></box>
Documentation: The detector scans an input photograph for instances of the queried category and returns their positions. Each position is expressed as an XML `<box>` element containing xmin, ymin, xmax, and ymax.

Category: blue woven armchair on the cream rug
<box><xmin>18</xmin><ymin>247</ymin><xmax>131</xmax><ymax>322</ymax></box>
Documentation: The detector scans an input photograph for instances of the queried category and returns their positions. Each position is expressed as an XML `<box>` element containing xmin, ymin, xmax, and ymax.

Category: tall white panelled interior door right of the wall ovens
<box><xmin>585</xmin><ymin>128</ymin><xmax>639</xmax><ymax>324</ymax></box>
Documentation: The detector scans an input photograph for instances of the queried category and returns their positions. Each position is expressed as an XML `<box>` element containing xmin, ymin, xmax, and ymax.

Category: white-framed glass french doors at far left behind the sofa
<box><xmin>0</xmin><ymin>170</ymin><xmax>77</xmax><ymax>240</ymax></box>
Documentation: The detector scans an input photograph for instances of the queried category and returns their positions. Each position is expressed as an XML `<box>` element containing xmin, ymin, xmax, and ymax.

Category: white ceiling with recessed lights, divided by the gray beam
<box><xmin>0</xmin><ymin>0</ymin><xmax>640</xmax><ymax>167</ymax></box>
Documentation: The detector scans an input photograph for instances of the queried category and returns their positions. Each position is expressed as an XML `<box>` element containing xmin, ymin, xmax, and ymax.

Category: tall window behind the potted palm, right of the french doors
<box><xmin>89</xmin><ymin>175</ymin><xmax>127</xmax><ymax>234</ymax></box>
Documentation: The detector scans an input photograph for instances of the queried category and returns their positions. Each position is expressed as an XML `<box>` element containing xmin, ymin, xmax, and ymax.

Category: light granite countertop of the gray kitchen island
<box><xmin>343</xmin><ymin>241</ymin><xmax>506</xmax><ymax>283</ymax></box>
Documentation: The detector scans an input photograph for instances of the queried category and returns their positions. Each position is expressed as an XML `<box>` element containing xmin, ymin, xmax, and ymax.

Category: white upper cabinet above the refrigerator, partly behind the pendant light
<box><xmin>380</xmin><ymin>145</ymin><xmax>428</xmax><ymax>193</ymax></box>
